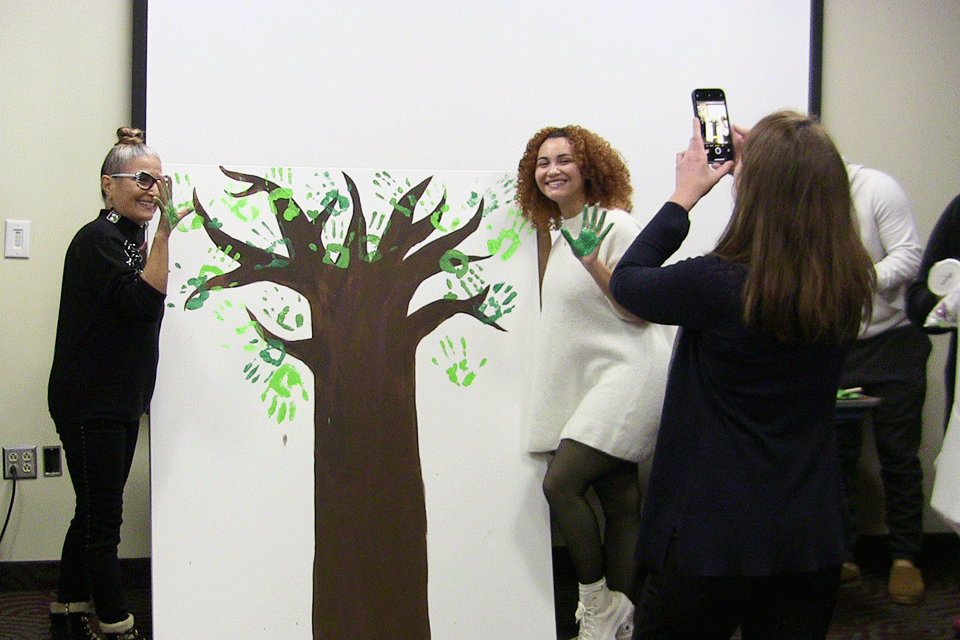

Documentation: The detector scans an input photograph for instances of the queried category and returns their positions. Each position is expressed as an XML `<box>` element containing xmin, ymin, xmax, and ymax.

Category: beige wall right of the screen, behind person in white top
<box><xmin>821</xmin><ymin>0</ymin><xmax>960</xmax><ymax>532</ymax></box>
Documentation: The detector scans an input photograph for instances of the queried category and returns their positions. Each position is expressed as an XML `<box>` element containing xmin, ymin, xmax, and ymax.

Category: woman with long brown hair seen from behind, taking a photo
<box><xmin>610</xmin><ymin>112</ymin><xmax>874</xmax><ymax>640</ymax></box>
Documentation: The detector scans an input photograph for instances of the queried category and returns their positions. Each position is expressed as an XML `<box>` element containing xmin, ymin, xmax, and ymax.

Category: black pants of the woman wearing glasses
<box><xmin>57</xmin><ymin>420</ymin><xmax>140</xmax><ymax>624</ymax></box>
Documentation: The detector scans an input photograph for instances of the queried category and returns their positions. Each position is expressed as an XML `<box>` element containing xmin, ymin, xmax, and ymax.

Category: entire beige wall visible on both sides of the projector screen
<box><xmin>0</xmin><ymin>0</ymin><xmax>960</xmax><ymax>561</ymax></box>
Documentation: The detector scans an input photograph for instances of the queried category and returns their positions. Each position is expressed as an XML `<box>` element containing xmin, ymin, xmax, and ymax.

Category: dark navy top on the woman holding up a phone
<box><xmin>610</xmin><ymin>202</ymin><xmax>848</xmax><ymax>576</ymax></box>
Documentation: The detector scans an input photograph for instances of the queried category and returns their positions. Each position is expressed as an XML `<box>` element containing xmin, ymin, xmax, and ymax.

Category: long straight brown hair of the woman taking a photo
<box><xmin>713</xmin><ymin>111</ymin><xmax>876</xmax><ymax>342</ymax></box>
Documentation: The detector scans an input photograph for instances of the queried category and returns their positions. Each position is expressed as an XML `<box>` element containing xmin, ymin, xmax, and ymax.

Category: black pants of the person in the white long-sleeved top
<box><xmin>837</xmin><ymin>326</ymin><xmax>930</xmax><ymax>561</ymax></box>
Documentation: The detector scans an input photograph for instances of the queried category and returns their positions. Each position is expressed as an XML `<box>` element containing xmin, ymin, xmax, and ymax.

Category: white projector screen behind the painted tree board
<box><xmin>141</xmin><ymin>0</ymin><xmax>819</xmax><ymax>213</ymax></box>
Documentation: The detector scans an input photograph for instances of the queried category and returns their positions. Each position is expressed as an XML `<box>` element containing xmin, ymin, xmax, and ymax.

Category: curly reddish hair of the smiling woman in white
<box><xmin>517</xmin><ymin>125</ymin><xmax>633</xmax><ymax>230</ymax></box>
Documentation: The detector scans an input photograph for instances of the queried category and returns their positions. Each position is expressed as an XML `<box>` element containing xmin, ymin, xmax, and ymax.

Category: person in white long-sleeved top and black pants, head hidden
<box><xmin>838</xmin><ymin>163</ymin><xmax>930</xmax><ymax>604</ymax></box>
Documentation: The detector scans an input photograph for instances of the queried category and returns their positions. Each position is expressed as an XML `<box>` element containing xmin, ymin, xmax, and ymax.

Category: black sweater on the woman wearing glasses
<box><xmin>47</xmin><ymin>210</ymin><xmax>165</xmax><ymax>428</ymax></box>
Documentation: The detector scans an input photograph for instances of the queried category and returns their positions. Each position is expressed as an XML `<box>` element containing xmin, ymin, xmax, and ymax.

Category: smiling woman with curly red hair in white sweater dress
<box><xmin>517</xmin><ymin>126</ymin><xmax>673</xmax><ymax>640</ymax></box>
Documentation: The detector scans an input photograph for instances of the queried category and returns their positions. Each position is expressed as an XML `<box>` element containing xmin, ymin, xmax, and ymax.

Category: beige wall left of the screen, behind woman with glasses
<box><xmin>0</xmin><ymin>0</ymin><xmax>150</xmax><ymax>561</ymax></box>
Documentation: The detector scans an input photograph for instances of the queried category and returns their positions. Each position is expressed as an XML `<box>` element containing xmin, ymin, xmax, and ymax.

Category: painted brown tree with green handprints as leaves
<box><xmin>185</xmin><ymin>167</ymin><xmax>519</xmax><ymax>640</ymax></box>
